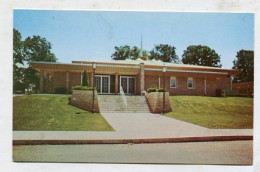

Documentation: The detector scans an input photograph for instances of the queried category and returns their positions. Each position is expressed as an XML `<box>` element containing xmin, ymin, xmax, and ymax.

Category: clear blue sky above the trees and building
<box><xmin>14</xmin><ymin>10</ymin><xmax>254</xmax><ymax>68</ymax></box>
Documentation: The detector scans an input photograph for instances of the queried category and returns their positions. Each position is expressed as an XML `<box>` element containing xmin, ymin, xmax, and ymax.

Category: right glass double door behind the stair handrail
<box><xmin>120</xmin><ymin>76</ymin><xmax>135</xmax><ymax>94</ymax></box>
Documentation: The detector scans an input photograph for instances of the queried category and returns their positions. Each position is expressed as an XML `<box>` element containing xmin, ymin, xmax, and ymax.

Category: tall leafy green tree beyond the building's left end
<box><xmin>13</xmin><ymin>29</ymin><xmax>57</xmax><ymax>91</ymax></box>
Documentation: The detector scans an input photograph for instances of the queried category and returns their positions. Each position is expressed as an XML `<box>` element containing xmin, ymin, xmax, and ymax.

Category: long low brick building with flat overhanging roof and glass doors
<box><xmin>31</xmin><ymin>59</ymin><xmax>239</xmax><ymax>96</ymax></box>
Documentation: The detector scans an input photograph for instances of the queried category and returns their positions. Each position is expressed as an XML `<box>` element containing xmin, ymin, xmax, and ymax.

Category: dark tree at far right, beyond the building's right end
<box><xmin>233</xmin><ymin>50</ymin><xmax>254</xmax><ymax>82</ymax></box>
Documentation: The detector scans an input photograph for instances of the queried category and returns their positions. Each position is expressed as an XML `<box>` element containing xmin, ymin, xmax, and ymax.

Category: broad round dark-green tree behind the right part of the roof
<box><xmin>182</xmin><ymin>45</ymin><xmax>222</xmax><ymax>67</ymax></box>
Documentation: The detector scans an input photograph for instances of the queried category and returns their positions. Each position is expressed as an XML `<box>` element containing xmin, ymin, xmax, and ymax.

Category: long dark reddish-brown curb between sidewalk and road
<box><xmin>13</xmin><ymin>136</ymin><xmax>253</xmax><ymax>145</ymax></box>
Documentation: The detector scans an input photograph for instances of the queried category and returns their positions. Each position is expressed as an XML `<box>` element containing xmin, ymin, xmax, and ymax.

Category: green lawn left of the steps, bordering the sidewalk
<box><xmin>13</xmin><ymin>95</ymin><xmax>113</xmax><ymax>131</ymax></box>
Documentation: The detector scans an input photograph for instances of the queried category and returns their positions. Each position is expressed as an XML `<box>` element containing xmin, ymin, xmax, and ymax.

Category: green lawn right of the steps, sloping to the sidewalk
<box><xmin>166</xmin><ymin>96</ymin><xmax>253</xmax><ymax>128</ymax></box>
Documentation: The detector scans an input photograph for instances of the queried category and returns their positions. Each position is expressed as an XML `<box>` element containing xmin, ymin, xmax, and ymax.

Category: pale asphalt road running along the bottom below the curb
<box><xmin>13</xmin><ymin>141</ymin><xmax>253</xmax><ymax>164</ymax></box>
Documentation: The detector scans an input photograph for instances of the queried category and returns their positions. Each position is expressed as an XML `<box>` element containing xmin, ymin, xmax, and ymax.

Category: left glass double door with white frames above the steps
<box><xmin>95</xmin><ymin>75</ymin><xmax>110</xmax><ymax>94</ymax></box>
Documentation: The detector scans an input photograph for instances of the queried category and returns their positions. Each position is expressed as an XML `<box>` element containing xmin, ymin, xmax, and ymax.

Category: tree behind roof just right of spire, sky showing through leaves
<box><xmin>149</xmin><ymin>44</ymin><xmax>179</xmax><ymax>62</ymax></box>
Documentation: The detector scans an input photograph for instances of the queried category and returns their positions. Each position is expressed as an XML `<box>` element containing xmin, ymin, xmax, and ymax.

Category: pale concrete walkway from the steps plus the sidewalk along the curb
<box><xmin>13</xmin><ymin>113</ymin><xmax>253</xmax><ymax>140</ymax></box>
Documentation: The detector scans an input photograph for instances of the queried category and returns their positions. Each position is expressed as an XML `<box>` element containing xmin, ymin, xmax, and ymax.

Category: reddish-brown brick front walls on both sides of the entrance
<box><xmin>50</xmin><ymin>72</ymin><xmax>230</xmax><ymax>96</ymax></box>
